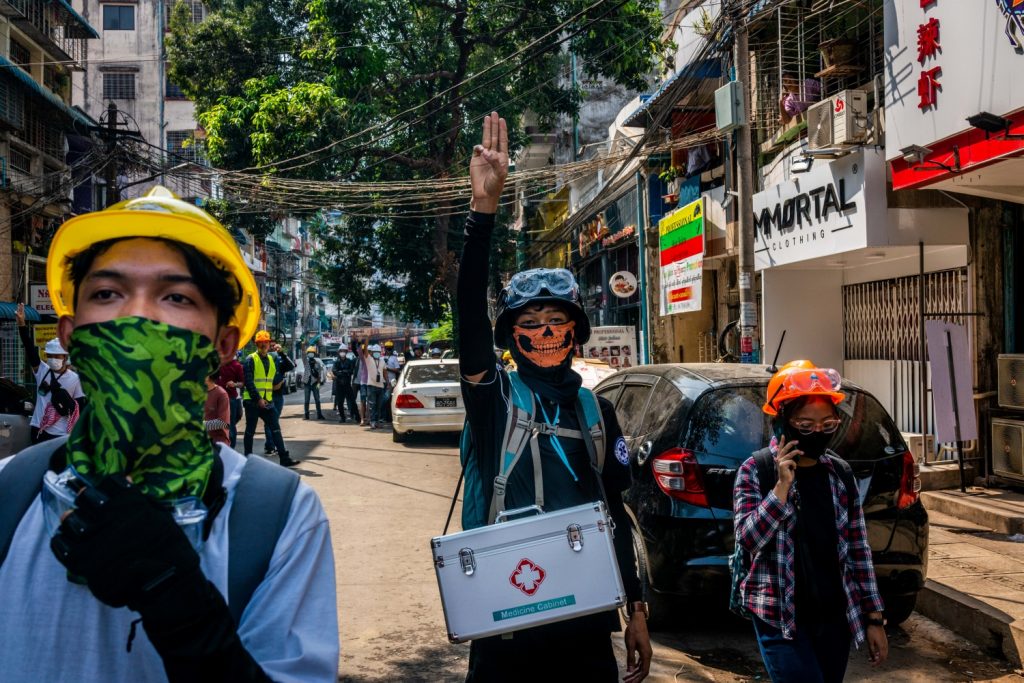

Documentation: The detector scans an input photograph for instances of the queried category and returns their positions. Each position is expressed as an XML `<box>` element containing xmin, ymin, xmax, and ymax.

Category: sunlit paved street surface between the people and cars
<box><xmin>270</xmin><ymin>391</ymin><xmax>1024</xmax><ymax>682</ymax></box>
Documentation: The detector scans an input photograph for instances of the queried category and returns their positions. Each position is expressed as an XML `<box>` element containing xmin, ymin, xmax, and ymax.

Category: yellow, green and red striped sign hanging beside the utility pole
<box><xmin>657</xmin><ymin>198</ymin><xmax>705</xmax><ymax>315</ymax></box>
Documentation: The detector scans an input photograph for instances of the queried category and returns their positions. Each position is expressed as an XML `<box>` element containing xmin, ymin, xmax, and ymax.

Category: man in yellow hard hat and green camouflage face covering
<box><xmin>0</xmin><ymin>188</ymin><xmax>339</xmax><ymax>683</ymax></box>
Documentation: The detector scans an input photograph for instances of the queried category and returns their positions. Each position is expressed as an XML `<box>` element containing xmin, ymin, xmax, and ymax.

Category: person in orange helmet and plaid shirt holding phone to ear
<box><xmin>733</xmin><ymin>361</ymin><xmax>889</xmax><ymax>683</ymax></box>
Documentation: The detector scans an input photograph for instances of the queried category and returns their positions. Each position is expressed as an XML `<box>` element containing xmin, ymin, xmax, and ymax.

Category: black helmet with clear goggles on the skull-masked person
<box><xmin>495</xmin><ymin>268</ymin><xmax>590</xmax><ymax>348</ymax></box>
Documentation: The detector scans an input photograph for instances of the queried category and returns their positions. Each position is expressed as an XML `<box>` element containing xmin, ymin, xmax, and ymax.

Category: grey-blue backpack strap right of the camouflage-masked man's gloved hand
<box><xmin>227</xmin><ymin>456</ymin><xmax>299</xmax><ymax>625</ymax></box>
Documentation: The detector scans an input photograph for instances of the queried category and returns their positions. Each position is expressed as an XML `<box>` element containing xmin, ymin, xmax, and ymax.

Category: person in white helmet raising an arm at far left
<box><xmin>14</xmin><ymin>303</ymin><xmax>85</xmax><ymax>443</ymax></box>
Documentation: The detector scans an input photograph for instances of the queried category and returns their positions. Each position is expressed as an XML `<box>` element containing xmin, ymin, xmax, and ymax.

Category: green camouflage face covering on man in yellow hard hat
<box><xmin>68</xmin><ymin>317</ymin><xmax>220</xmax><ymax>501</ymax></box>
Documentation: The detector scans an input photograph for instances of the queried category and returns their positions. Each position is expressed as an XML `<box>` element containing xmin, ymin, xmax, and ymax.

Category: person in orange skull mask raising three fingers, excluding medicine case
<box><xmin>460</xmin><ymin>114</ymin><xmax>651</xmax><ymax>683</ymax></box>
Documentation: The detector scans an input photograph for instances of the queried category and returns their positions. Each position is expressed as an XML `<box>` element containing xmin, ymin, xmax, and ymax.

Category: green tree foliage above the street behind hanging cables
<box><xmin>168</xmin><ymin>0</ymin><xmax>662</xmax><ymax>322</ymax></box>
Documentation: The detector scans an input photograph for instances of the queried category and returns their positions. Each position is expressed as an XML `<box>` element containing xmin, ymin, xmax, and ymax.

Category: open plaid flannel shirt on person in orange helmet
<box><xmin>732</xmin><ymin>449</ymin><xmax>883</xmax><ymax>647</ymax></box>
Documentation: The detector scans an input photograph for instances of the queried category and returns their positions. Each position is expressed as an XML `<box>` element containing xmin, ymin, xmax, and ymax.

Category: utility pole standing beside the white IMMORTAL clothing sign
<box><xmin>732</xmin><ymin>3</ymin><xmax>761</xmax><ymax>362</ymax></box>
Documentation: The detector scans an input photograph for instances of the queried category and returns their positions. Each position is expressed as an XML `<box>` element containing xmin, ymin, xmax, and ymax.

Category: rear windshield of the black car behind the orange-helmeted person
<box><xmin>686</xmin><ymin>387</ymin><xmax>905</xmax><ymax>461</ymax></box>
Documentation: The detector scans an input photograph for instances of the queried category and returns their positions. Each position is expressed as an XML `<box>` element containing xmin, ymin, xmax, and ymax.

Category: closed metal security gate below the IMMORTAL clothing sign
<box><xmin>843</xmin><ymin>267</ymin><xmax>969</xmax><ymax>433</ymax></box>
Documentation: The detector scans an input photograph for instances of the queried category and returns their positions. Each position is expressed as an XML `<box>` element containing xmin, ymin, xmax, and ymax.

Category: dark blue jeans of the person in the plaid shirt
<box><xmin>754</xmin><ymin>614</ymin><xmax>851</xmax><ymax>683</ymax></box>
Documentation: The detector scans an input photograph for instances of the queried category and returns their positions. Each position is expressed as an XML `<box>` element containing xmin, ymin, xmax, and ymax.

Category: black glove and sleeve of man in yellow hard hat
<box><xmin>50</xmin><ymin>476</ymin><xmax>269</xmax><ymax>682</ymax></box>
